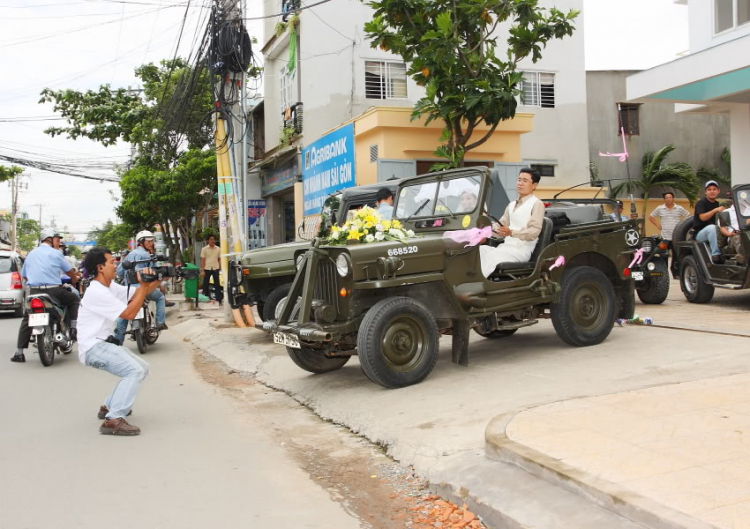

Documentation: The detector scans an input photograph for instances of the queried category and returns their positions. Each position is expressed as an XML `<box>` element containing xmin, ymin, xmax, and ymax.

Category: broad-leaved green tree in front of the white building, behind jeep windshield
<box><xmin>365</xmin><ymin>0</ymin><xmax>578</xmax><ymax>168</ymax></box>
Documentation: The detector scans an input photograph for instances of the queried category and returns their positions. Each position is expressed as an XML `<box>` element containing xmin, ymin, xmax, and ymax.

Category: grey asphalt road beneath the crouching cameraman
<box><xmin>0</xmin><ymin>313</ymin><xmax>360</xmax><ymax>529</ymax></box>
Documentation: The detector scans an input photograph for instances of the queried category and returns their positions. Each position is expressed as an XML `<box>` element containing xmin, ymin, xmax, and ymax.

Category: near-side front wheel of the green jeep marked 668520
<box><xmin>357</xmin><ymin>297</ymin><xmax>438</xmax><ymax>388</ymax></box>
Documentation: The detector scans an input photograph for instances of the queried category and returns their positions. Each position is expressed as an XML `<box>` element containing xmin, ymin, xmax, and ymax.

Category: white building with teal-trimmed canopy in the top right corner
<box><xmin>627</xmin><ymin>0</ymin><xmax>750</xmax><ymax>185</ymax></box>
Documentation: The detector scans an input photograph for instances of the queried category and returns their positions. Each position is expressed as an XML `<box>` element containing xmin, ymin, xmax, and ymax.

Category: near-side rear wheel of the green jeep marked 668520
<box><xmin>550</xmin><ymin>266</ymin><xmax>617</xmax><ymax>347</ymax></box>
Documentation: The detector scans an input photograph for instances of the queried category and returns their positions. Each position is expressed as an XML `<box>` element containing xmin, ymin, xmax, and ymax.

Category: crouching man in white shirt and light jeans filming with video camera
<box><xmin>78</xmin><ymin>248</ymin><xmax>161</xmax><ymax>435</ymax></box>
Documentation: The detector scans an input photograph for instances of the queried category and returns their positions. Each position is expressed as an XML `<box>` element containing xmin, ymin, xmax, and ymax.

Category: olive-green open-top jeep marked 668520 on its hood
<box><xmin>257</xmin><ymin>168</ymin><xmax>638</xmax><ymax>388</ymax></box>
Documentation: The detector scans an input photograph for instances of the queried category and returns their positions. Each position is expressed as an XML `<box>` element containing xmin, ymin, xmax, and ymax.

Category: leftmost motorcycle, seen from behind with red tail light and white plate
<box><xmin>26</xmin><ymin>288</ymin><xmax>73</xmax><ymax>367</ymax></box>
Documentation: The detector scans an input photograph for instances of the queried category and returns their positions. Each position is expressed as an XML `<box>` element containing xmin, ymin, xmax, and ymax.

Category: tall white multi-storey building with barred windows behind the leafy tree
<box><xmin>251</xmin><ymin>0</ymin><xmax>589</xmax><ymax>244</ymax></box>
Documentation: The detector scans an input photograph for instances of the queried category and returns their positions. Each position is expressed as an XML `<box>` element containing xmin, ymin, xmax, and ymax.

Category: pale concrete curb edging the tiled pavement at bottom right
<box><xmin>485</xmin><ymin>408</ymin><xmax>716</xmax><ymax>529</ymax></box>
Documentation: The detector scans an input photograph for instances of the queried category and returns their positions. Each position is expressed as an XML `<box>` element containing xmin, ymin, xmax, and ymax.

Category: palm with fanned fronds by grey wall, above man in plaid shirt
<box><xmin>610</xmin><ymin>145</ymin><xmax>700</xmax><ymax>218</ymax></box>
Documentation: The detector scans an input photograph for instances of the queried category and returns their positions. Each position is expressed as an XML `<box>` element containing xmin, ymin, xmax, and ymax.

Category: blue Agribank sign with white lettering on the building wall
<box><xmin>302</xmin><ymin>124</ymin><xmax>355</xmax><ymax>215</ymax></box>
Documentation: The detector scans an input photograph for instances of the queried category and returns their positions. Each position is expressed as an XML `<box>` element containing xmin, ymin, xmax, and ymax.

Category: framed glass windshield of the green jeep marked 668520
<box><xmin>395</xmin><ymin>175</ymin><xmax>481</xmax><ymax>219</ymax></box>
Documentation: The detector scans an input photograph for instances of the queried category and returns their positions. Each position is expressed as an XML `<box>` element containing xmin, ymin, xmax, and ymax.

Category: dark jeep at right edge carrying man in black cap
<box><xmin>674</xmin><ymin>184</ymin><xmax>750</xmax><ymax>303</ymax></box>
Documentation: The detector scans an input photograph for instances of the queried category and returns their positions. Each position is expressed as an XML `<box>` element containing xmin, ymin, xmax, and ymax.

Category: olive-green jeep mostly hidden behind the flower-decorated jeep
<box><xmin>234</xmin><ymin>180</ymin><xmax>398</xmax><ymax>321</ymax></box>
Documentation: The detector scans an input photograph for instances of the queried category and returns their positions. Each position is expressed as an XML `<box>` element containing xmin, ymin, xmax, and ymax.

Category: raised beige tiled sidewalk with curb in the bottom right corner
<box><xmin>486</xmin><ymin>374</ymin><xmax>750</xmax><ymax>529</ymax></box>
